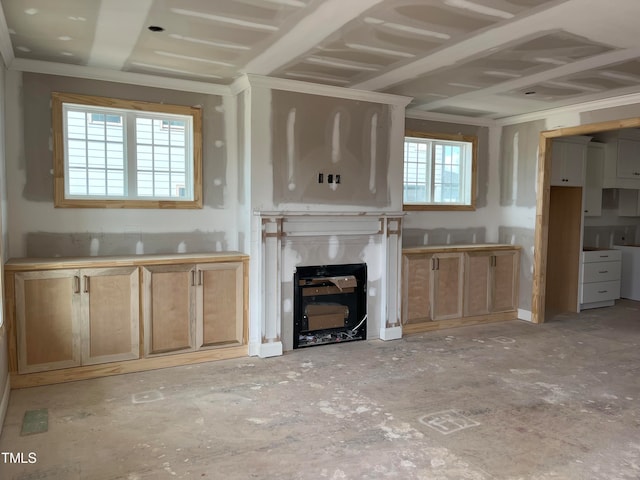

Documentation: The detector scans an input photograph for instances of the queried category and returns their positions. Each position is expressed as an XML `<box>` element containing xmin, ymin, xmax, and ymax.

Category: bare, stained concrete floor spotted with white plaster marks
<box><xmin>0</xmin><ymin>301</ymin><xmax>640</xmax><ymax>480</ymax></box>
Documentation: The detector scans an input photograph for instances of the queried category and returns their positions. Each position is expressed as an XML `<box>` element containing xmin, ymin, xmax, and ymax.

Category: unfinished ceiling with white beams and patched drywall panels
<box><xmin>0</xmin><ymin>0</ymin><xmax>640</xmax><ymax>119</ymax></box>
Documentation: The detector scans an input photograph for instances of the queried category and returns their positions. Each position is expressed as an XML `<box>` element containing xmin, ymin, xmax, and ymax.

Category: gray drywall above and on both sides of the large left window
<box><xmin>21</xmin><ymin>73</ymin><xmax>227</xmax><ymax>208</ymax></box>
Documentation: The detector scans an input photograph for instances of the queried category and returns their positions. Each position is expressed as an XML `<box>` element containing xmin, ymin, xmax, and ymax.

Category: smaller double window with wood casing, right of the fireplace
<box><xmin>403</xmin><ymin>132</ymin><xmax>476</xmax><ymax>210</ymax></box>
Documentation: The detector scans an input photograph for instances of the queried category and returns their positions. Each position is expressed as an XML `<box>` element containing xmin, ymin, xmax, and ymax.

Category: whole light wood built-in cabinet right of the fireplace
<box><xmin>402</xmin><ymin>245</ymin><xmax>520</xmax><ymax>333</ymax></box>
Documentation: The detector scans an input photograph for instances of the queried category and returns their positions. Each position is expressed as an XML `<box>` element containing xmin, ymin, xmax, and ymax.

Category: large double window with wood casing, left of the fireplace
<box><xmin>53</xmin><ymin>93</ymin><xmax>202</xmax><ymax>208</ymax></box>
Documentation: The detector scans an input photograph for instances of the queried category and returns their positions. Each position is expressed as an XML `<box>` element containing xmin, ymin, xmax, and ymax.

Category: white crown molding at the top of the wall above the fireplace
<box><xmin>242</xmin><ymin>74</ymin><xmax>412</xmax><ymax>107</ymax></box>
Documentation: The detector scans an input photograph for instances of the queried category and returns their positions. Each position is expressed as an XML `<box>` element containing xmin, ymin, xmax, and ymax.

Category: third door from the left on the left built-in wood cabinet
<box><xmin>142</xmin><ymin>265</ymin><xmax>195</xmax><ymax>355</ymax></box>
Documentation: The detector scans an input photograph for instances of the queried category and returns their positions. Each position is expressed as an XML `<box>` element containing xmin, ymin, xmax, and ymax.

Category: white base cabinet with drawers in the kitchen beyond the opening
<box><xmin>580</xmin><ymin>249</ymin><xmax>621</xmax><ymax>310</ymax></box>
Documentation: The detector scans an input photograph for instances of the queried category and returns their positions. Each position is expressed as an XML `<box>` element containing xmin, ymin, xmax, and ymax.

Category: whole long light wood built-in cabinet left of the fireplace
<box><xmin>4</xmin><ymin>252</ymin><xmax>249</xmax><ymax>388</ymax></box>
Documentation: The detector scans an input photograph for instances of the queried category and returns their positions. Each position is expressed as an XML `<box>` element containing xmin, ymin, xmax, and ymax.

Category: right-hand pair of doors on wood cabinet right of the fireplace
<box><xmin>464</xmin><ymin>250</ymin><xmax>520</xmax><ymax>316</ymax></box>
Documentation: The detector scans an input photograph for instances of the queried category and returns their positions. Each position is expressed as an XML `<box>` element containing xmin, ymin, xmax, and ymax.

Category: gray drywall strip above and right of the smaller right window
<box><xmin>405</xmin><ymin>118</ymin><xmax>489</xmax><ymax>208</ymax></box>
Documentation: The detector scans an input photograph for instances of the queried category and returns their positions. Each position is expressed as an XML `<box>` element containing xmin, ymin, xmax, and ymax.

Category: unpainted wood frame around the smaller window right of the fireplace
<box><xmin>402</xmin><ymin>130</ymin><xmax>478</xmax><ymax>211</ymax></box>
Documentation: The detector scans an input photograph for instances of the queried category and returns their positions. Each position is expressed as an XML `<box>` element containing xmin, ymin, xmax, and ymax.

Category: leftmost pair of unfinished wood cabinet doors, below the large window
<box><xmin>15</xmin><ymin>267</ymin><xmax>139</xmax><ymax>373</ymax></box>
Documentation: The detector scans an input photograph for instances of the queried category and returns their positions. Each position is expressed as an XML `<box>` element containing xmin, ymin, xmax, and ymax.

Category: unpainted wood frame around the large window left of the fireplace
<box><xmin>51</xmin><ymin>92</ymin><xmax>202</xmax><ymax>209</ymax></box>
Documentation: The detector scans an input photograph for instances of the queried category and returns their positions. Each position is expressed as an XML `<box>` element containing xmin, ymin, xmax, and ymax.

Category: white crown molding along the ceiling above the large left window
<box><xmin>9</xmin><ymin>58</ymin><xmax>231</xmax><ymax>96</ymax></box>
